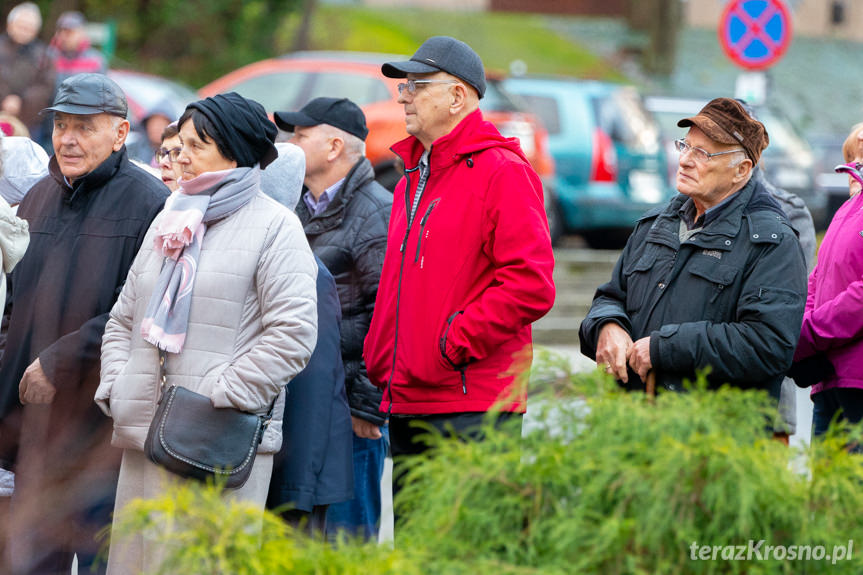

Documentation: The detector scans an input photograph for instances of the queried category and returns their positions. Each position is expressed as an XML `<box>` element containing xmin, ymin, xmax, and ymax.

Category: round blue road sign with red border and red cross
<box><xmin>719</xmin><ymin>0</ymin><xmax>791</xmax><ymax>70</ymax></box>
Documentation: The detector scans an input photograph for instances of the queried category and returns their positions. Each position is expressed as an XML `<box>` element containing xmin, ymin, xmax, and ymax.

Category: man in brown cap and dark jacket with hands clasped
<box><xmin>579</xmin><ymin>98</ymin><xmax>806</xmax><ymax>404</ymax></box>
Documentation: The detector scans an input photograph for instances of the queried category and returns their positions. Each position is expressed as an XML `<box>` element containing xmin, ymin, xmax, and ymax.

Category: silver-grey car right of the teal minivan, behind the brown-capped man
<box><xmin>645</xmin><ymin>96</ymin><xmax>829</xmax><ymax>229</ymax></box>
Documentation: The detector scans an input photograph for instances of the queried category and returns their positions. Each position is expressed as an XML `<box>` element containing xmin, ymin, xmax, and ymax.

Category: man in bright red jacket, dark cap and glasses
<box><xmin>364</xmin><ymin>36</ymin><xmax>554</xmax><ymax>512</ymax></box>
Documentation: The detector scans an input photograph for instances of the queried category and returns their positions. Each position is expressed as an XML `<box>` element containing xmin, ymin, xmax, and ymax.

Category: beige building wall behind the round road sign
<box><xmin>683</xmin><ymin>0</ymin><xmax>863</xmax><ymax>41</ymax></box>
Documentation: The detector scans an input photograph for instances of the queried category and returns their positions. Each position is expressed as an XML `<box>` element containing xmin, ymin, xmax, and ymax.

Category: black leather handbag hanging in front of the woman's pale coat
<box><xmin>144</xmin><ymin>353</ymin><xmax>275</xmax><ymax>489</ymax></box>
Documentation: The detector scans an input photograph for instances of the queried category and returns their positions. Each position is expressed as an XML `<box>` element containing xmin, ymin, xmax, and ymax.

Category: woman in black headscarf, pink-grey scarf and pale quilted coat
<box><xmin>96</xmin><ymin>93</ymin><xmax>317</xmax><ymax>573</ymax></box>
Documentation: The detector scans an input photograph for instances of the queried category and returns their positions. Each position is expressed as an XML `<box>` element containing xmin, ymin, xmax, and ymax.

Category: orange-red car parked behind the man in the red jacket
<box><xmin>198</xmin><ymin>52</ymin><xmax>554</xmax><ymax>190</ymax></box>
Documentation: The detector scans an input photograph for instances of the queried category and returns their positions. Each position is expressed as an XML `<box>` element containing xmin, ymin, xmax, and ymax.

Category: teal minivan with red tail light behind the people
<box><xmin>503</xmin><ymin>76</ymin><xmax>676</xmax><ymax>248</ymax></box>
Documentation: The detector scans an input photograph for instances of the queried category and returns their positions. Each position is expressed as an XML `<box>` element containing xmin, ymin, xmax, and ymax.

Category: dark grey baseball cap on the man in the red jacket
<box><xmin>381</xmin><ymin>36</ymin><xmax>485</xmax><ymax>98</ymax></box>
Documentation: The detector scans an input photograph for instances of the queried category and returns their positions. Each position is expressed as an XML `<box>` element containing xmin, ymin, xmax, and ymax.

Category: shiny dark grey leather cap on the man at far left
<box><xmin>40</xmin><ymin>74</ymin><xmax>129</xmax><ymax>118</ymax></box>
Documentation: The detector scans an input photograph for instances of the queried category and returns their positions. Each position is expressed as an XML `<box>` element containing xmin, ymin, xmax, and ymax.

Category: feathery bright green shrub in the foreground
<box><xmin>111</xmin><ymin>358</ymin><xmax>863</xmax><ymax>575</ymax></box>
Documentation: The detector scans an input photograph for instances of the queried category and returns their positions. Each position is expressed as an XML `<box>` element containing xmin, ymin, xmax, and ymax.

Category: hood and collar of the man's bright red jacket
<box><xmin>390</xmin><ymin>109</ymin><xmax>530</xmax><ymax>169</ymax></box>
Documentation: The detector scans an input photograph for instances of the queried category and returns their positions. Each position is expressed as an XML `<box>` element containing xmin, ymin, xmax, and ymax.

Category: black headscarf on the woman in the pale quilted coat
<box><xmin>184</xmin><ymin>92</ymin><xmax>279</xmax><ymax>169</ymax></box>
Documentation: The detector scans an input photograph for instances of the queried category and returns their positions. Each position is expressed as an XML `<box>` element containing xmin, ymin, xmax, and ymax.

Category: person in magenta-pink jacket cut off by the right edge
<box><xmin>794</xmin><ymin>124</ymin><xmax>863</xmax><ymax>436</ymax></box>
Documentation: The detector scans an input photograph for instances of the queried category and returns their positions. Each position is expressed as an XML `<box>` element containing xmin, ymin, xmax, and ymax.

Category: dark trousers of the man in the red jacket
<box><xmin>390</xmin><ymin>412</ymin><xmax>524</xmax><ymax>527</ymax></box>
